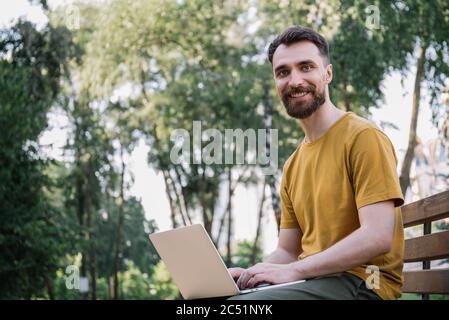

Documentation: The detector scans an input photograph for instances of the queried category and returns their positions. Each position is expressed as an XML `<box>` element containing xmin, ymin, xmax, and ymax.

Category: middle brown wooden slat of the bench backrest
<box><xmin>404</xmin><ymin>231</ymin><xmax>449</xmax><ymax>262</ymax></box>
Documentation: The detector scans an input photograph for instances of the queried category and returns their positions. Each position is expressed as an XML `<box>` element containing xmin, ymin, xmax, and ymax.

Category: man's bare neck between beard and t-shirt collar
<box><xmin>299</xmin><ymin>100</ymin><xmax>345</xmax><ymax>142</ymax></box>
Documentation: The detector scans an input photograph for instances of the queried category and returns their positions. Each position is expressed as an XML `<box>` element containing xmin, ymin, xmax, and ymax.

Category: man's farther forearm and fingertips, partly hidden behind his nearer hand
<box><xmin>228</xmin><ymin>228</ymin><xmax>302</xmax><ymax>281</ymax></box>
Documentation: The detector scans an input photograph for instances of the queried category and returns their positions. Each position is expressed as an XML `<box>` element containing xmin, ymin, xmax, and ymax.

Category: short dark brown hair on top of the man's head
<box><xmin>268</xmin><ymin>26</ymin><xmax>330</xmax><ymax>64</ymax></box>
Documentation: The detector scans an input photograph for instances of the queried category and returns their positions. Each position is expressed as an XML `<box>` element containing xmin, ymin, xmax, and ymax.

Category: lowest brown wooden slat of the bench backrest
<box><xmin>402</xmin><ymin>269</ymin><xmax>449</xmax><ymax>293</ymax></box>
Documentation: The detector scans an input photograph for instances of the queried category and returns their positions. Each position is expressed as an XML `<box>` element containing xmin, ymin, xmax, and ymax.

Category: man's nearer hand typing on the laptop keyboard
<box><xmin>237</xmin><ymin>263</ymin><xmax>301</xmax><ymax>289</ymax></box>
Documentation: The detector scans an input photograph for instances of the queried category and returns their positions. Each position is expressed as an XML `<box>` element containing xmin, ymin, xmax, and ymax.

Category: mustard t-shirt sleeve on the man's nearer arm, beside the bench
<box><xmin>350</xmin><ymin>128</ymin><xmax>404</xmax><ymax>209</ymax></box>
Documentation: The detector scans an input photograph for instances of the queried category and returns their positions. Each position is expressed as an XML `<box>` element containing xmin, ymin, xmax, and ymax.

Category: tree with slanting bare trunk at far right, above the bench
<box><xmin>384</xmin><ymin>0</ymin><xmax>449</xmax><ymax>194</ymax></box>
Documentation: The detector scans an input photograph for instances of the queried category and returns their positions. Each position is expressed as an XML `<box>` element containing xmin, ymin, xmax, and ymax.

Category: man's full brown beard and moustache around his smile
<box><xmin>282</xmin><ymin>86</ymin><xmax>326</xmax><ymax>119</ymax></box>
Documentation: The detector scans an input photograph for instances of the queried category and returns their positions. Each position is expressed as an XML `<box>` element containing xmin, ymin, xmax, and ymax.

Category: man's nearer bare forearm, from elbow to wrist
<box><xmin>292</xmin><ymin>228</ymin><xmax>389</xmax><ymax>279</ymax></box>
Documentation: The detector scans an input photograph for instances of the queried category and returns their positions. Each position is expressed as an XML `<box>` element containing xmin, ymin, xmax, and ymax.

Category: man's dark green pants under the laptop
<box><xmin>229</xmin><ymin>272</ymin><xmax>380</xmax><ymax>300</ymax></box>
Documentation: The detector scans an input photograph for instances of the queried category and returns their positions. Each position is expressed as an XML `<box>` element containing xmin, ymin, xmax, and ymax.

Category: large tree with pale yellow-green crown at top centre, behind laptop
<box><xmin>76</xmin><ymin>0</ymin><xmax>261</xmax><ymax>244</ymax></box>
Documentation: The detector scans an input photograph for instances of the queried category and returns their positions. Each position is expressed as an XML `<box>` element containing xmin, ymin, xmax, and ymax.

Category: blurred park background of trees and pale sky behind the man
<box><xmin>0</xmin><ymin>0</ymin><xmax>449</xmax><ymax>299</ymax></box>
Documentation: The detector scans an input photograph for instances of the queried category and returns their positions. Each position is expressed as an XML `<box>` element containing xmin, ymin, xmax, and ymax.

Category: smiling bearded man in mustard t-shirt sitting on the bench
<box><xmin>229</xmin><ymin>26</ymin><xmax>404</xmax><ymax>299</ymax></box>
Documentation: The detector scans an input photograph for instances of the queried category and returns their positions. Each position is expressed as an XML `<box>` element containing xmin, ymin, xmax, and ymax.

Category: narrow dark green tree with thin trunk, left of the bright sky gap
<box><xmin>63</xmin><ymin>87</ymin><xmax>113</xmax><ymax>300</ymax></box>
